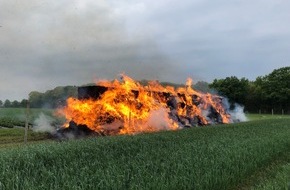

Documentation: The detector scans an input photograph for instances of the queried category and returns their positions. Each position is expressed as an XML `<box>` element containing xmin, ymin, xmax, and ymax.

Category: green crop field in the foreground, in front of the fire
<box><xmin>0</xmin><ymin>118</ymin><xmax>290</xmax><ymax>190</ymax></box>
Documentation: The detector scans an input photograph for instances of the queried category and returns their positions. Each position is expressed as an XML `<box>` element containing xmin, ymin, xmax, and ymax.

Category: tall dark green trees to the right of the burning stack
<box><xmin>209</xmin><ymin>67</ymin><xmax>290</xmax><ymax>114</ymax></box>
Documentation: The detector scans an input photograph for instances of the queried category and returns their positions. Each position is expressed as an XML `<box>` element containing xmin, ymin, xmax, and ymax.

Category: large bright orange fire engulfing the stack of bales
<box><xmin>59</xmin><ymin>75</ymin><xmax>231</xmax><ymax>134</ymax></box>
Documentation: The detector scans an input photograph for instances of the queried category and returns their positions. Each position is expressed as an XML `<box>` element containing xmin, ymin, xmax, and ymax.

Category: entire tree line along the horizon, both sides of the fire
<box><xmin>0</xmin><ymin>67</ymin><xmax>290</xmax><ymax>113</ymax></box>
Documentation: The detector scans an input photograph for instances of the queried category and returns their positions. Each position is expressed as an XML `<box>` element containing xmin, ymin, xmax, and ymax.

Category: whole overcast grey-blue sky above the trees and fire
<box><xmin>0</xmin><ymin>0</ymin><xmax>290</xmax><ymax>101</ymax></box>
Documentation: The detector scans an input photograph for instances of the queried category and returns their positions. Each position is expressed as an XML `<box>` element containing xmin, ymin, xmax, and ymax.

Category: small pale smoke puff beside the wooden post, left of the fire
<box><xmin>33</xmin><ymin>113</ymin><xmax>56</xmax><ymax>133</ymax></box>
